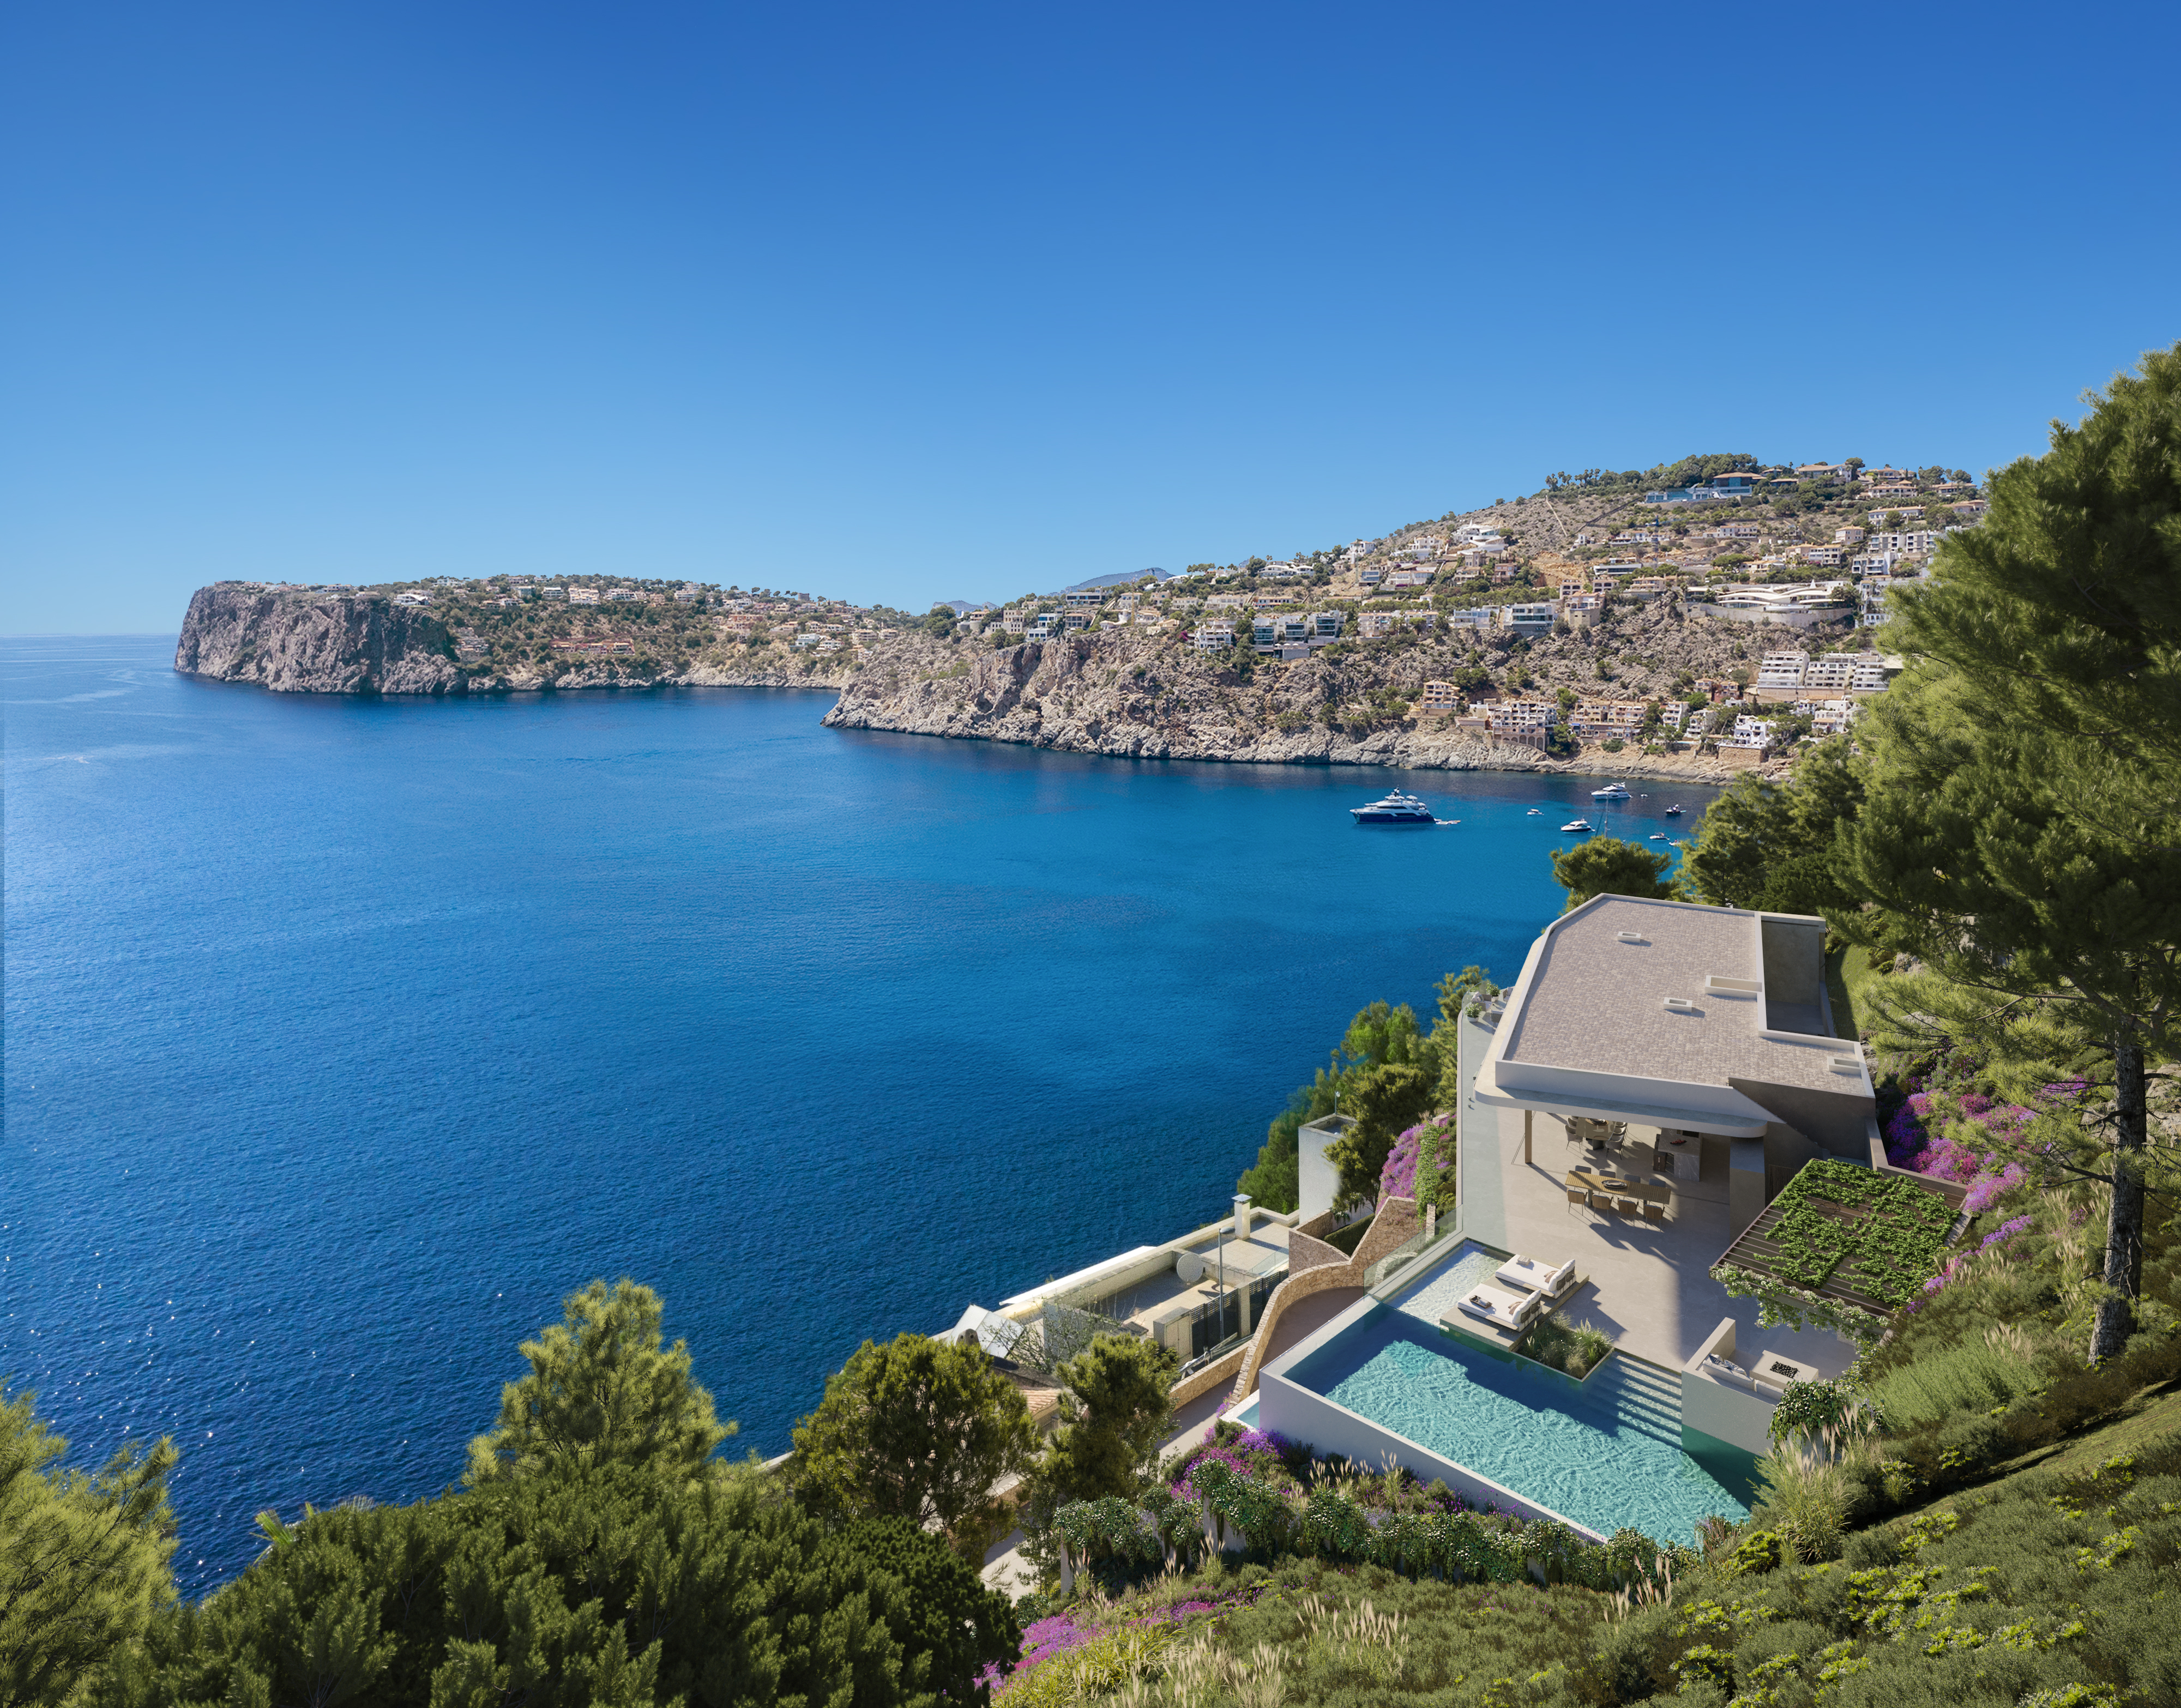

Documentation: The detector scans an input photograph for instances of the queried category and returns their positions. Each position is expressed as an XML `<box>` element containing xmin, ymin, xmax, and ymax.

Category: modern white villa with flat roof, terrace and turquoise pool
<box><xmin>955</xmin><ymin>897</ymin><xmax>1963</xmax><ymax>1579</ymax></box>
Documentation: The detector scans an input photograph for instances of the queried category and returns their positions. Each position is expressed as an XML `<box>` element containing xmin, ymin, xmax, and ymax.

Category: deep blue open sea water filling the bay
<box><xmin>0</xmin><ymin>637</ymin><xmax>1710</xmax><ymax>1590</ymax></box>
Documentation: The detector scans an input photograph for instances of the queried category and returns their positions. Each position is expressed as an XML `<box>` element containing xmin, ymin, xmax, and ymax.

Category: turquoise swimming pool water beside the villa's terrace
<box><xmin>1287</xmin><ymin>1246</ymin><xmax>1756</xmax><ymax>1544</ymax></box>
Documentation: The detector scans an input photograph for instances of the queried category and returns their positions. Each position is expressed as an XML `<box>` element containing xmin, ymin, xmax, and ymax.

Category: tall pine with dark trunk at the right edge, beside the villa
<box><xmin>1836</xmin><ymin>347</ymin><xmax>2181</xmax><ymax>1359</ymax></box>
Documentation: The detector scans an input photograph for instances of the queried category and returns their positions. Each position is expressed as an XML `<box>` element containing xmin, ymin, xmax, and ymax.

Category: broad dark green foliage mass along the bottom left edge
<box><xmin>105</xmin><ymin>1464</ymin><xmax>931</xmax><ymax>1708</ymax></box>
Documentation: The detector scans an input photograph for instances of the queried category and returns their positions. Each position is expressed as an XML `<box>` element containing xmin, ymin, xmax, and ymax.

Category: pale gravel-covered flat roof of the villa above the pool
<box><xmin>1487</xmin><ymin>897</ymin><xmax>1869</xmax><ymax>1121</ymax></box>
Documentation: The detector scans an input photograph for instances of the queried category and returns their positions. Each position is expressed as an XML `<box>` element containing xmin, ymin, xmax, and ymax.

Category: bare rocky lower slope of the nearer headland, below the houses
<box><xmin>824</xmin><ymin>602</ymin><xmax>1839</xmax><ymax>781</ymax></box>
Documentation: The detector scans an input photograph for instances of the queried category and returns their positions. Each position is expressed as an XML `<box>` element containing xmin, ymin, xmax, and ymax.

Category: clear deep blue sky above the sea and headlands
<box><xmin>0</xmin><ymin>0</ymin><xmax>2181</xmax><ymax>632</ymax></box>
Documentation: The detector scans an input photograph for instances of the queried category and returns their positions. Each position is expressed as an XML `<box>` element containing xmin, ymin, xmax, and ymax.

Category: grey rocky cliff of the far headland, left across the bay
<box><xmin>174</xmin><ymin>582</ymin><xmax>848</xmax><ymax>693</ymax></box>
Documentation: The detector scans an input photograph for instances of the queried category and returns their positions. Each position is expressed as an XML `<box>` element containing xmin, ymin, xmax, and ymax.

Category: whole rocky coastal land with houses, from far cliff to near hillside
<box><xmin>174</xmin><ymin>454</ymin><xmax>1985</xmax><ymax>776</ymax></box>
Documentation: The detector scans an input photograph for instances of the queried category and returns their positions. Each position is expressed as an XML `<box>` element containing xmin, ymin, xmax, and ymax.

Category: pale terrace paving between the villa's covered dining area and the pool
<box><xmin>1459</xmin><ymin>1019</ymin><xmax>1856</xmax><ymax>1377</ymax></box>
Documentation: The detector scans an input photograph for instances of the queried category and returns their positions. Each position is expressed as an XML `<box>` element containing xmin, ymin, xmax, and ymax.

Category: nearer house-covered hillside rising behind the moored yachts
<box><xmin>829</xmin><ymin>456</ymin><xmax>1983</xmax><ymax>776</ymax></box>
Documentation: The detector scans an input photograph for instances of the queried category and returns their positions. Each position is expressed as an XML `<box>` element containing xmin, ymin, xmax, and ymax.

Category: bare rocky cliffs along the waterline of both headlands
<box><xmin>174</xmin><ymin>582</ymin><xmax>1806</xmax><ymax>783</ymax></box>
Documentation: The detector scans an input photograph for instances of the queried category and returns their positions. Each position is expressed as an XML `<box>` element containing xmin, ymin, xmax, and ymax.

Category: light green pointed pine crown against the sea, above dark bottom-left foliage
<box><xmin>469</xmin><ymin>1278</ymin><xmax>737</xmax><ymax>1483</ymax></box>
